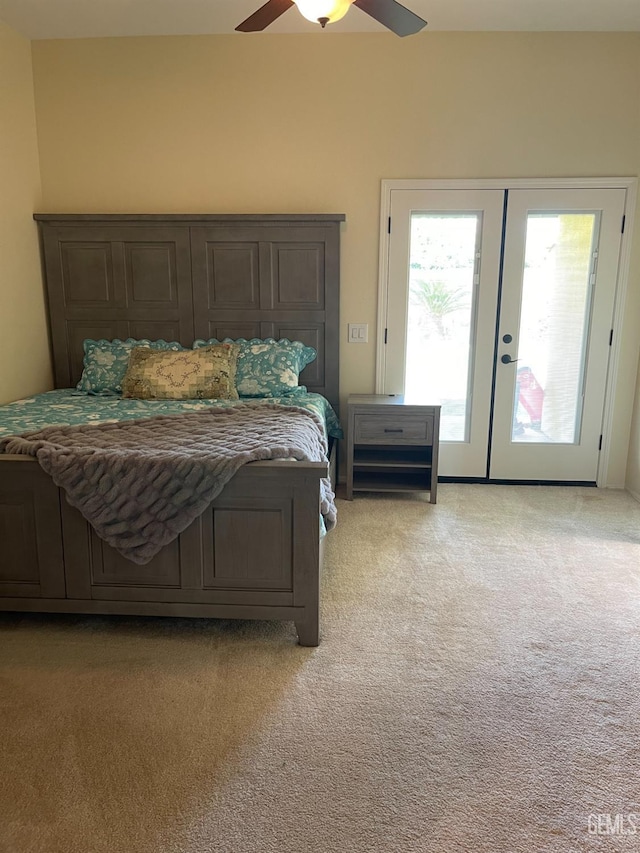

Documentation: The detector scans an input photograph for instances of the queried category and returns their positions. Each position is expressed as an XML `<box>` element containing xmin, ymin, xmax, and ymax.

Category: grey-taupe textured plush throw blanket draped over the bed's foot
<box><xmin>0</xmin><ymin>403</ymin><xmax>336</xmax><ymax>563</ymax></box>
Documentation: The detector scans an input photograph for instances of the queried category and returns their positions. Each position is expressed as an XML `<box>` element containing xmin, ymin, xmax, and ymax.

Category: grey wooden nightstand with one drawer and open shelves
<box><xmin>347</xmin><ymin>394</ymin><xmax>440</xmax><ymax>503</ymax></box>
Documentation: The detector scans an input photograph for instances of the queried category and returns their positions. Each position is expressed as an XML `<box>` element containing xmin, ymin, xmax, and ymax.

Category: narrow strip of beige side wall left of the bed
<box><xmin>0</xmin><ymin>22</ymin><xmax>51</xmax><ymax>403</ymax></box>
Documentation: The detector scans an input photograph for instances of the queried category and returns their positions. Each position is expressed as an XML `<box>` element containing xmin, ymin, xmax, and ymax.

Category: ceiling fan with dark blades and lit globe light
<box><xmin>236</xmin><ymin>0</ymin><xmax>427</xmax><ymax>36</ymax></box>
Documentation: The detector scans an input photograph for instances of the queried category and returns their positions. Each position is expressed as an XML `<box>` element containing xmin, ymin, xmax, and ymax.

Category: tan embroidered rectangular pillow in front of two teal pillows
<box><xmin>122</xmin><ymin>344</ymin><xmax>239</xmax><ymax>400</ymax></box>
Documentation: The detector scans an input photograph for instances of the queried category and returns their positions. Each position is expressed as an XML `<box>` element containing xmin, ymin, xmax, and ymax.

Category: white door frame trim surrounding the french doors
<box><xmin>376</xmin><ymin>177</ymin><xmax>638</xmax><ymax>486</ymax></box>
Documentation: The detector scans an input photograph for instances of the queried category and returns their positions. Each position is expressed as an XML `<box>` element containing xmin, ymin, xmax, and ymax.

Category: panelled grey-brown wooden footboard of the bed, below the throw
<box><xmin>0</xmin><ymin>455</ymin><xmax>328</xmax><ymax>646</ymax></box>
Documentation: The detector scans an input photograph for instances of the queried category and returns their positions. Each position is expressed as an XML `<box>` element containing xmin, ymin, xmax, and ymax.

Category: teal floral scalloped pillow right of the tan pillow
<box><xmin>193</xmin><ymin>338</ymin><xmax>317</xmax><ymax>397</ymax></box>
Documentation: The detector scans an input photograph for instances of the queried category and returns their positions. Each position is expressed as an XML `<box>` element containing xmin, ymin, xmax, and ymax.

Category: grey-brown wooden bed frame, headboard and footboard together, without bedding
<box><xmin>0</xmin><ymin>214</ymin><xmax>344</xmax><ymax>645</ymax></box>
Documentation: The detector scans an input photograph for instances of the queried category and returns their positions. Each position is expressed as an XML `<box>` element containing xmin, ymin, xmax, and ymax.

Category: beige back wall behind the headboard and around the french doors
<box><xmin>27</xmin><ymin>32</ymin><xmax>640</xmax><ymax>485</ymax></box>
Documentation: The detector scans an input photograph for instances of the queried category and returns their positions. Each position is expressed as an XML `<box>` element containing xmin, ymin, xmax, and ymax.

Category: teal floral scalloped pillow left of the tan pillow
<box><xmin>76</xmin><ymin>338</ymin><xmax>184</xmax><ymax>396</ymax></box>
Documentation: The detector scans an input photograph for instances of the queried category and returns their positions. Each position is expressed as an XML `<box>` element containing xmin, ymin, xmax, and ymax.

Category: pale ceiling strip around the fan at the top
<box><xmin>0</xmin><ymin>0</ymin><xmax>640</xmax><ymax>39</ymax></box>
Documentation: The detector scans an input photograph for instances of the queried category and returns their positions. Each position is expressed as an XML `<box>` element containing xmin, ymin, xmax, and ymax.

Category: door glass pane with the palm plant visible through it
<box><xmin>405</xmin><ymin>212</ymin><xmax>481</xmax><ymax>441</ymax></box>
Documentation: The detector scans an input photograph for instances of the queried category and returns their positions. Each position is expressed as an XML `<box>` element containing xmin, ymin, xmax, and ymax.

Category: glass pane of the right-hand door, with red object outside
<box><xmin>511</xmin><ymin>212</ymin><xmax>599</xmax><ymax>444</ymax></box>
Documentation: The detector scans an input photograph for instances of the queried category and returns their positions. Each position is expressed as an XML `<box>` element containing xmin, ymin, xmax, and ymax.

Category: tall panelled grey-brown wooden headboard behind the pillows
<box><xmin>34</xmin><ymin>213</ymin><xmax>345</xmax><ymax>411</ymax></box>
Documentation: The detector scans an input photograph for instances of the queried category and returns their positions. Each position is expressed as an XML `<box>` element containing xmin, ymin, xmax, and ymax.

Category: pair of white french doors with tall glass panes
<box><xmin>378</xmin><ymin>181</ymin><xmax>626</xmax><ymax>482</ymax></box>
